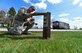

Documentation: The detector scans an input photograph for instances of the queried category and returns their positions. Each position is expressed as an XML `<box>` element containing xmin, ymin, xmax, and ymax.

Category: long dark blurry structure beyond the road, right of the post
<box><xmin>52</xmin><ymin>21</ymin><xmax>70</xmax><ymax>29</ymax></box>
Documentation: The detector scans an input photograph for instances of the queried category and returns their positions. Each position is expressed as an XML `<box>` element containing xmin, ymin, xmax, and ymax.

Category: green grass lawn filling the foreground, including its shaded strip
<box><xmin>0</xmin><ymin>31</ymin><xmax>82</xmax><ymax>53</ymax></box>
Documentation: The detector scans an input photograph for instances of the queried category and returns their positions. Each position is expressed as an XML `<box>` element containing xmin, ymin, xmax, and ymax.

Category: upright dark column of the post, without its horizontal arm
<box><xmin>43</xmin><ymin>12</ymin><xmax>51</xmax><ymax>38</ymax></box>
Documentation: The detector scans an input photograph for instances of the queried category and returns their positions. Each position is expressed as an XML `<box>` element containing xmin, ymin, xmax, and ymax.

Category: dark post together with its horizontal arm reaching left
<box><xmin>33</xmin><ymin>12</ymin><xmax>51</xmax><ymax>39</ymax></box>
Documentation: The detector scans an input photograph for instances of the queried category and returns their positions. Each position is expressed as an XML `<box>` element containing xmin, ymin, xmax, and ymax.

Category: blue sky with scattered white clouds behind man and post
<box><xmin>0</xmin><ymin>0</ymin><xmax>82</xmax><ymax>29</ymax></box>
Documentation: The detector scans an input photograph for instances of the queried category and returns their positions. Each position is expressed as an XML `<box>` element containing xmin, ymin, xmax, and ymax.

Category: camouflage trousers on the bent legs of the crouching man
<box><xmin>7</xmin><ymin>20</ymin><xmax>34</xmax><ymax>34</ymax></box>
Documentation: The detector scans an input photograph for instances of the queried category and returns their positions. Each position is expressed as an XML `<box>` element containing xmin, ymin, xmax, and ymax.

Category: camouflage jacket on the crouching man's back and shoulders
<box><xmin>15</xmin><ymin>9</ymin><xmax>30</xmax><ymax>22</ymax></box>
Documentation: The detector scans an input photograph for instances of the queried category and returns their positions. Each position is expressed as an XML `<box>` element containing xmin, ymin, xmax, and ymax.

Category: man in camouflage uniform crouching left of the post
<box><xmin>7</xmin><ymin>6</ymin><xmax>35</xmax><ymax>34</ymax></box>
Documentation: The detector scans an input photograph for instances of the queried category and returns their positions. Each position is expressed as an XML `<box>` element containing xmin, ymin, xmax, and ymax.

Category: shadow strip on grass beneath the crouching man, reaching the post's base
<box><xmin>0</xmin><ymin>32</ymin><xmax>44</xmax><ymax>39</ymax></box>
